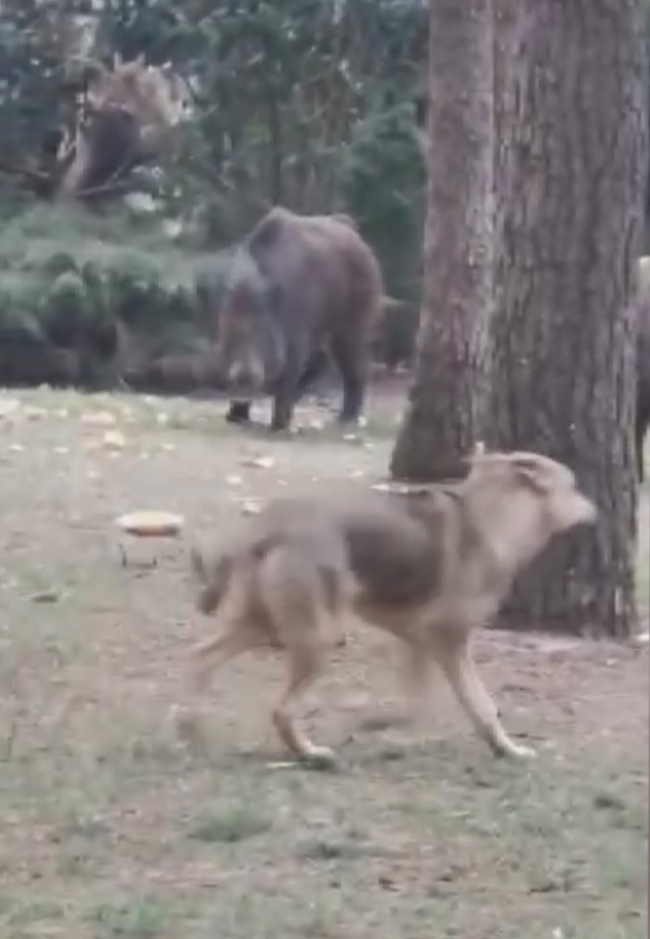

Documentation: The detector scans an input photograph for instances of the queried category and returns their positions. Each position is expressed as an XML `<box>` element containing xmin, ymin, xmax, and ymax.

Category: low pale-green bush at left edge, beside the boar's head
<box><xmin>0</xmin><ymin>206</ymin><xmax>230</xmax><ymax>385</ymax></box>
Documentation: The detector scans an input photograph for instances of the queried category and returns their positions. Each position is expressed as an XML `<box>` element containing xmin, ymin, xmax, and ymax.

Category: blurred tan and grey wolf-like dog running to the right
<box><xmin>184</xmin><ymin>453</ymin><xmax>596</xmax><ymax>758</ymax></box>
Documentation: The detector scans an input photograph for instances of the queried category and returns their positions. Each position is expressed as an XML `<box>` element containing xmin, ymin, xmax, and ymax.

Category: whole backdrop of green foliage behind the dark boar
<box><xmin>0</xmin><ymin>0</ymin><xmax>427</xmax><ymax>380</ymax></box>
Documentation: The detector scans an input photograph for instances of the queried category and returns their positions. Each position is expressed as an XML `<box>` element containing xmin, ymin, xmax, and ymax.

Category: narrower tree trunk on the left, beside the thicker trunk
<box><xmin>391</xmin><ymin>0</ymin><xmax>493</xmax><ymax>480</ymax></box>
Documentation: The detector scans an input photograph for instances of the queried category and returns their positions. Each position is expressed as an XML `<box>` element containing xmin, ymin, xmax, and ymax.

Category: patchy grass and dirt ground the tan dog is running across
<box><xmin>0</xmin><ymin>390</ymin><xmax>648</xmax><ymax>939</ymax></box>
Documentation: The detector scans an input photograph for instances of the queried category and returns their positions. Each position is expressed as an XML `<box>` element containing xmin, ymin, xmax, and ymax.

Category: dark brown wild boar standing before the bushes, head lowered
<box><xmin>219</xmin><ymin>207</ymin><xmax>383</xmax><ymax>430</ymax></box>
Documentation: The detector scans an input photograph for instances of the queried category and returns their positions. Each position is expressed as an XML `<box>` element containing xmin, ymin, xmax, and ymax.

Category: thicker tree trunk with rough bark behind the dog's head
<box><xmin>488</xmin><ymin>0</ymin><xmax>647</xmax><ymax>635</ymax></box>
